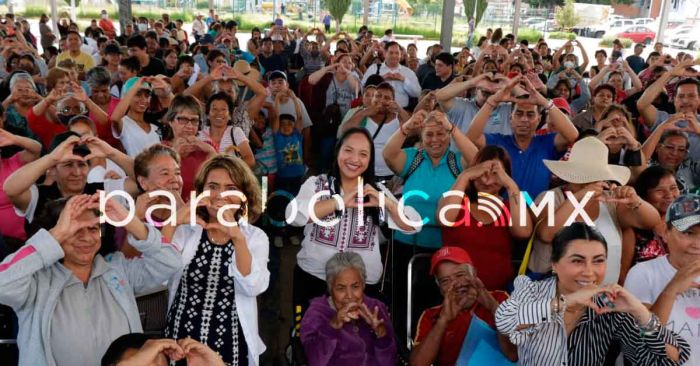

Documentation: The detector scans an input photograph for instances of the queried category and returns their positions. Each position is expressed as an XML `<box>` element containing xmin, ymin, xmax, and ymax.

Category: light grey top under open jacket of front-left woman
<box><xmin>50</xmin><ymin>255</ymin><xmax>131</xmax><ymax>366</ymax></box>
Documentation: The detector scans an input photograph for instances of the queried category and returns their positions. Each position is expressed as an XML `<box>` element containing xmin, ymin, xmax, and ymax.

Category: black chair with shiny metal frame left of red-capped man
<box><xmin>406</xmin><ymin>253</ymin><xmax>442</xmax><ymax>350</ymax></box>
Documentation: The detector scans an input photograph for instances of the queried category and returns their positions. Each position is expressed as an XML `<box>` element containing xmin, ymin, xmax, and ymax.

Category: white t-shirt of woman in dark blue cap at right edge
<box><xmin>625</xmin><ymin>256</ymin><xmax>700</xmax><ymax>365</ymax></box>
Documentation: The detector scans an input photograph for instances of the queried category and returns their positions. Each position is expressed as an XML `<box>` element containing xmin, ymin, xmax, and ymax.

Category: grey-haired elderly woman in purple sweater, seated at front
<box><xmin>301</xmin><ymin>252</ymin><xmax>397</xmax><ymax>366</ymax></box>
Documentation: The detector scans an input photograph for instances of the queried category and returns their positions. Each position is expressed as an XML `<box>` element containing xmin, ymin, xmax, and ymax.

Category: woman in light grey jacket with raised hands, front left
<box><xmin>0</xmin><ymin>194</ymin><xmax>182</xmax><ymax>366</ymax></box>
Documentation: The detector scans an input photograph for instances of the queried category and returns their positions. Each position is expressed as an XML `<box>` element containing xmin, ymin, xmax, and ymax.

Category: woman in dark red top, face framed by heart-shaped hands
<box><xmin>436</xmin><ymin>145</ymin><xmax>533</xmax><ymax>290</ymax></box>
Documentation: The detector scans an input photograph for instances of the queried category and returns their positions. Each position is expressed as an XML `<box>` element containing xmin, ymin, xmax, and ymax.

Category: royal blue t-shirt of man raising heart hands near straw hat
<box><xmin>484</xmin><ymin>133</ymin><xmax>563</xmax><ymax>199</ymax></box>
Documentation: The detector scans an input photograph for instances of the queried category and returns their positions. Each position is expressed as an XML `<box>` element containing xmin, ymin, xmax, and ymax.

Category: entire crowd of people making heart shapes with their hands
<box><xmin>0</xmin><ymin>9</ymin><xmax>700</xmax><ymax>366</ymax></box>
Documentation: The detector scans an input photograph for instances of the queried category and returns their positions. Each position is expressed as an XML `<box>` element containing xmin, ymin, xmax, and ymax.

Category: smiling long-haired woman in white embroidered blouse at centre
<box><xmin>285</xmin><ymin>128</ymin><xmax>422</xmax><ymax>315</ymax></box>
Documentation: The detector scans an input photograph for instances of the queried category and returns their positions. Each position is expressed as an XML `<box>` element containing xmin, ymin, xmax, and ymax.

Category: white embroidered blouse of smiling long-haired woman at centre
<box><xmin>285</xmin><ymin>175</ymin><xmax>422</xmax><ymax>284</ymax></box>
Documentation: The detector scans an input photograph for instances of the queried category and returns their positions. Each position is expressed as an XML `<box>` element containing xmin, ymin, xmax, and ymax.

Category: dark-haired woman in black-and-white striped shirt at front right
<box><xmin>496</xmin><ymin>222</ymin><xmax>690</xmax><ymax>366</ymax></box>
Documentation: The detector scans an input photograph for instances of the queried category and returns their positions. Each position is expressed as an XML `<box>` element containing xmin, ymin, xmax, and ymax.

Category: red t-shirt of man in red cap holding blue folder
<box><xmin>415</xmin><ymin>291</ymin><xmax>508</xmax><ymax>366</ymax></box>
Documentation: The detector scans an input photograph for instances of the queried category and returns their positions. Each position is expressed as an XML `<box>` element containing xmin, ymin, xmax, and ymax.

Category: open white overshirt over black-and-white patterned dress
<box><xmin>168</xmin><ymin>223</ymin><xmax>270</xmax><ymax>366</ymax></box>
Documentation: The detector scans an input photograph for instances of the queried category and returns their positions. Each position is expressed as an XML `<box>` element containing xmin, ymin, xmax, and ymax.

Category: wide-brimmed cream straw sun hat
<box><xmin>544</xmin><ymin>137</ymin><xmax>630</xmax><ymax>185</ymax></box>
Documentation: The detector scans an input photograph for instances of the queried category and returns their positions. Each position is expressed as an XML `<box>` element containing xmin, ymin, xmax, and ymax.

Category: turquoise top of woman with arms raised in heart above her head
<box><xmin>394</xmin><ymin>147</ymin><xmax>464</xmax><ymax>248</ymax></box>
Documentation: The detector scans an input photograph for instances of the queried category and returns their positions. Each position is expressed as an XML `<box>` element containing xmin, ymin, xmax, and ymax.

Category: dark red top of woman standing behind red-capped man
<box><xmin>442</xmin><ymin>201</ymin><xmax>515</xmax><ymax>291</ymax></box>
